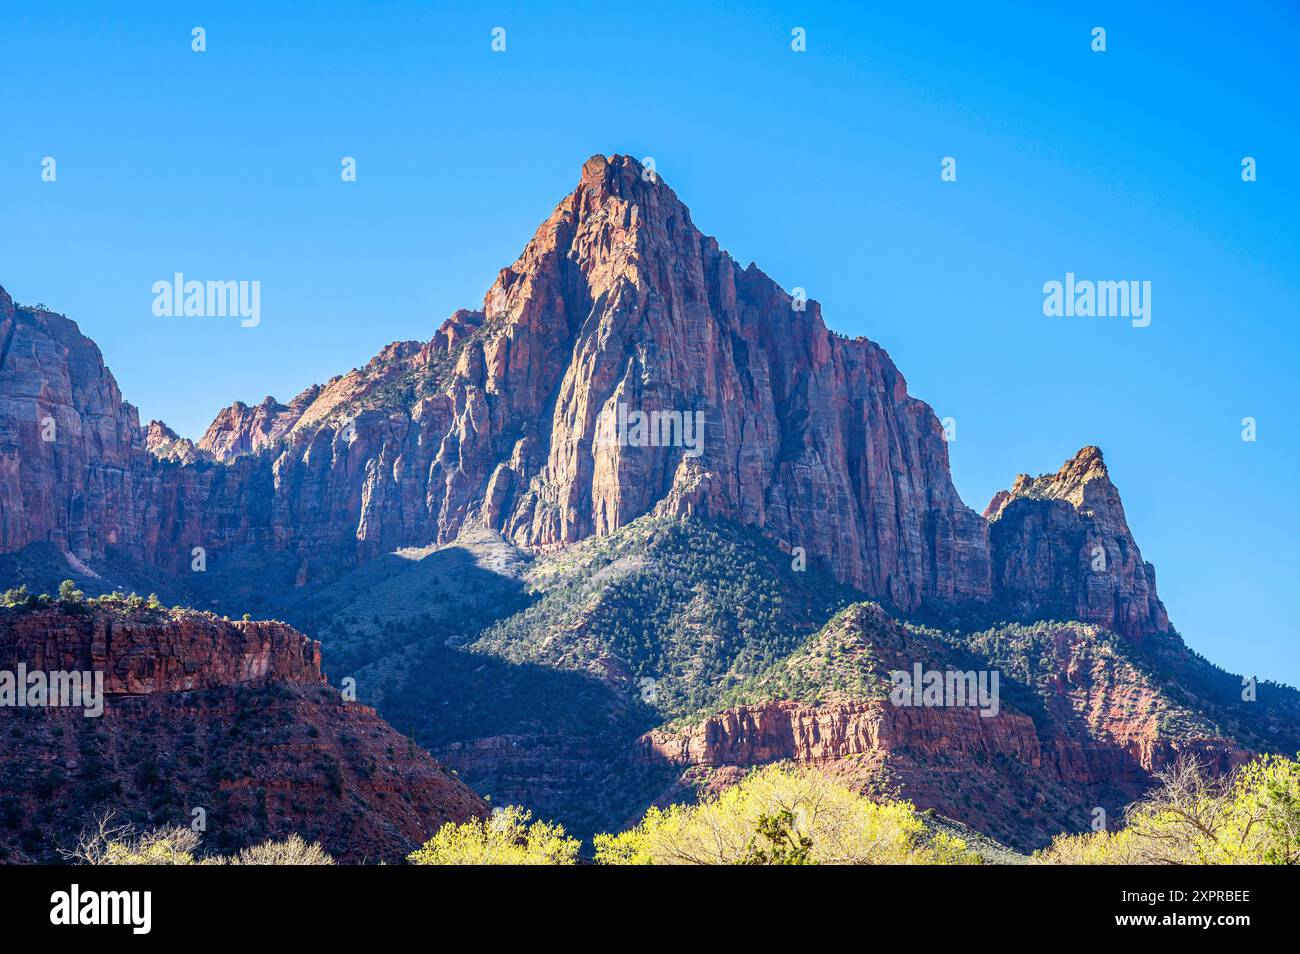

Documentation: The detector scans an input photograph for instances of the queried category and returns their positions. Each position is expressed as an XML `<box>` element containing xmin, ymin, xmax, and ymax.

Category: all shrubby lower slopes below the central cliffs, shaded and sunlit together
<box><xmin>236</xmin><ymin>517</ymin><xmax>1300</xmax><ymax>849</ymax></box>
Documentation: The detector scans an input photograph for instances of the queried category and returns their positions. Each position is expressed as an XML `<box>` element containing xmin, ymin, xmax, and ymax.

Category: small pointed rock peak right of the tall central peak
<box><xmin>984</xmin><ymin>447</ymin><xmax>1169</xmax><ymax>638</ymax></box>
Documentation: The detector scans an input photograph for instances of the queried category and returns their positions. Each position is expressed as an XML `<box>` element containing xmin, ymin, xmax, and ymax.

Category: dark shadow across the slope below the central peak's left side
<box><xmin>257</xmin><ymin>533</ymin><xmax>671</xmax><ymax>837</ymax></box>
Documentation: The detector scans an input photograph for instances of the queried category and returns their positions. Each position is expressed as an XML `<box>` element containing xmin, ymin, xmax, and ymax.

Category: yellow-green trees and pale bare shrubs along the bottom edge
<box><xmin>48</xmin><ymin>755</ymin><xmax>1300</xmax><ymax>866</ymax></box>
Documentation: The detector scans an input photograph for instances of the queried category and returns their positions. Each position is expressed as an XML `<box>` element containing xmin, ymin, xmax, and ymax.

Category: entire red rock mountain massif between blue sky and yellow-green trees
<box><xmin>0</xmin><ymin>155</ymin><xmax>1300</xmax><ymax>859</ymax></box>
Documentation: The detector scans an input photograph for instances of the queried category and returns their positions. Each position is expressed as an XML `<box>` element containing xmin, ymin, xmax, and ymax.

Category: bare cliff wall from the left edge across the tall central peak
<box><xmin>0</xmin><ymin>156</ymin><xmax>1170</xmax><ymax>626</ymax></box>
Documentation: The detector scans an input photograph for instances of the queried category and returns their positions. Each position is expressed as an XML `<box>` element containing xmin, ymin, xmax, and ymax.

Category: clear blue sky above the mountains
<box><xmin>0</xmin><ymin>3</ymin><xmax>1300</xmax><ymax>684</ymax></box>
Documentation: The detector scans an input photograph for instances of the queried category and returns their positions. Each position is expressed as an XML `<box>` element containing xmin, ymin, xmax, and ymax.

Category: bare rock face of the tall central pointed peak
<box><xmin>458</xmin><ymin>156</ymin><xmax>989</xmax><ymax>607</ymax></box>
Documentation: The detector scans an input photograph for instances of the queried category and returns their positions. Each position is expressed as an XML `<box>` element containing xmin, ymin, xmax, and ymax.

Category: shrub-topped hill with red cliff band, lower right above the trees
<box><xmin>641</xmin><ymin>604</ymin><xmax>1284</xmax><ymax>849</ymax></box>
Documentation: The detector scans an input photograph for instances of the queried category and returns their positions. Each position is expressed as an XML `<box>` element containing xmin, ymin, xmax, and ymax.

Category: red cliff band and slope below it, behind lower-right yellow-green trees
<box><xmin>638</xmin><ymin>681</ymin><xmax>1252</xmax><ymax>850</ymax></box>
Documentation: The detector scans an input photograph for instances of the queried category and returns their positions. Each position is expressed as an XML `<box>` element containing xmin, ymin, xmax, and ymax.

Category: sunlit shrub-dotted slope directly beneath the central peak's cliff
<box><xmin>471</xmin><ymin>517</ymin><xmax>854</xmax><ymax>719</ymax></box>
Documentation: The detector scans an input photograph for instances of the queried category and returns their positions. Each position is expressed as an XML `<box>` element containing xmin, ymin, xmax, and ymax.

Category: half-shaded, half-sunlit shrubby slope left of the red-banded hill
<box><xmin>291</xmin><ymin>517</ymin><xmax>852</xmax><ymax>833</ymax></box>
